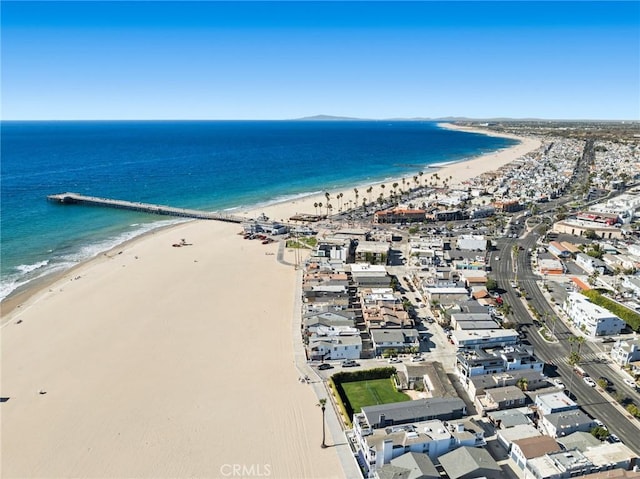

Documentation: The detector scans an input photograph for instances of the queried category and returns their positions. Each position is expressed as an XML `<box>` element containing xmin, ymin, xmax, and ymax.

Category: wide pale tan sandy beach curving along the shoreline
<box><xmin>0</xmin><ymin>125</ymin><xmax>539</xmax><ymax>479</ymax></box>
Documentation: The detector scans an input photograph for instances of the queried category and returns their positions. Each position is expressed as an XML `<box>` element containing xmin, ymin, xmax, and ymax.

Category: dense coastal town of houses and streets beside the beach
<box><xmin>258</xmin><ymin>124</ymin><xmax>640</xmax><ymax>479</ymax></box>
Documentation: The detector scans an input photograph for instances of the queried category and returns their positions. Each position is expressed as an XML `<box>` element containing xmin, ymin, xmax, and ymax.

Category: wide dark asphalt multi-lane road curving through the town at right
<box><xmin>491</xmin><ymin>228</ymin><xmax>640</xmax><ymax>454</ymax></box>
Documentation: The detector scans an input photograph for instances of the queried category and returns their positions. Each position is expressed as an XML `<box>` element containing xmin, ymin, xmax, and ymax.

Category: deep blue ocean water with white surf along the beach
<box><xmin>0</xmin><ymin>121</ymin><xmax>515</xmax><ymax>298</ymax></box>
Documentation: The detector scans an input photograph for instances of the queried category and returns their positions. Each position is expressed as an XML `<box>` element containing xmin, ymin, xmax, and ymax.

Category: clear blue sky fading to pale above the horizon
<box><xmin>1</xmin><ymin>0</ymin><xmax>640</xmax><ymax>120</ymax></box>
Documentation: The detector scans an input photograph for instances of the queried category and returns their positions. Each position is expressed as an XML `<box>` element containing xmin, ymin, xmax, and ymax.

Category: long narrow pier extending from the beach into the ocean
<box><xmin>47</xmin><ymin>193</ymin><xmax>248</xmax><ymax>223</ymax></box>
